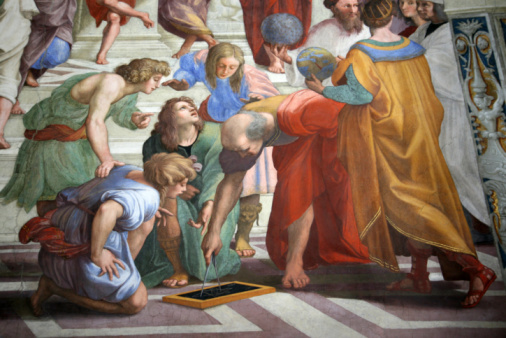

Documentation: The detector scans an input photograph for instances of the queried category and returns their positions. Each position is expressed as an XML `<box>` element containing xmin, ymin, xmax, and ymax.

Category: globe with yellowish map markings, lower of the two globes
<box><xmin>297</xmin><ymin>47</ymin><xmax>337</xmax><ymax>81</ymax></box>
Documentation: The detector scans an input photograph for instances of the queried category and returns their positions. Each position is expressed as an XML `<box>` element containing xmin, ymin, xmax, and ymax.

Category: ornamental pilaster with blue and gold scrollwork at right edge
<box><xmin>445</xmin><ymin>0</ymin><xmax>506</xmax><ymax>288</ymax></box>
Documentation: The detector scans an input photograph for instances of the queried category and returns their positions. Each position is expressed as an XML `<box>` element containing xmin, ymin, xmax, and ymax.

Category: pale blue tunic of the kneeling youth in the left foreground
<box><xmin>39</xmin><ymin>165</ymin><xmax>160</xmax><ymax>303</ymax></box>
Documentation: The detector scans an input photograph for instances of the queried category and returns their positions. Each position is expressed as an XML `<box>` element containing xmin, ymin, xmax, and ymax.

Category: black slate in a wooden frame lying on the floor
<box><xmin>162</xmin><ymin>282</ymin><xmax>276</xmax><ymax>309</ymax></box>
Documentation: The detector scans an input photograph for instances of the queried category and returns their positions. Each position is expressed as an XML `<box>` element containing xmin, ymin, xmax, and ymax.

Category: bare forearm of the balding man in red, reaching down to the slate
<box><xmin>201</xmin><ymin>171</ymin><xmax>246</xmax><ymax>265</ymax></box>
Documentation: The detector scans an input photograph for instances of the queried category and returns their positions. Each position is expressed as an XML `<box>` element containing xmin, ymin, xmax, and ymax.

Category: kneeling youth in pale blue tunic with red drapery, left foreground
<box><xmin>19</xmin><ymin>154</ymin><xmax>196</xmax><ymax>316</ymax></box>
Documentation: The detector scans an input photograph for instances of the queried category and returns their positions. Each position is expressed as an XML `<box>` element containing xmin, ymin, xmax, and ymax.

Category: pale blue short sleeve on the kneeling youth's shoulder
<box><xmin>101</xmin><ymin>189</ymin><xmax>160</xmax><ymax>231</ymax></box>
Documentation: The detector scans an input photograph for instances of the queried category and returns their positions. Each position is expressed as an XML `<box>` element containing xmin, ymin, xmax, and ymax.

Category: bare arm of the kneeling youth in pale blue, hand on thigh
<box><xmin>91</xmin><ymin>200</ymin><xmax>125</xmax><ymax>280</ymax></box>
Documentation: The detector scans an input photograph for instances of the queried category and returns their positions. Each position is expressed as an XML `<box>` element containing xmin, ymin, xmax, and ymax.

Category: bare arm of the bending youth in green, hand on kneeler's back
<box><xmin>86</xmin><ymin>75</ymin><xmax>124</xmax><ymax>177</ymax></box>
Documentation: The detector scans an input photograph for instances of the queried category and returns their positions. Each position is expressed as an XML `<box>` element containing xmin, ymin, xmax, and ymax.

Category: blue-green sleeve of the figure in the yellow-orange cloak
<box><xmin>323</xmin><ymin>65</ymin><xmax>373</xmax><ymax>105</ymax></box>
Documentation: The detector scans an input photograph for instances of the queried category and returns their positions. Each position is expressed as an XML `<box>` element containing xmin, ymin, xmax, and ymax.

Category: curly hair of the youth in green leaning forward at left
<box><xmin>114</xmin><ymin>58</ymin><xmax>170</xmax><ymax>84</ymax></box>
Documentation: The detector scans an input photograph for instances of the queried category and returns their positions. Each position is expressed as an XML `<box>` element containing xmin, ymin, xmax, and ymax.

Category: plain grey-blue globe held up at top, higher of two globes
<box><xmin>260</xmin><ymin>13</ymin><xmax>304</xmax><ymax>46</ymax></box>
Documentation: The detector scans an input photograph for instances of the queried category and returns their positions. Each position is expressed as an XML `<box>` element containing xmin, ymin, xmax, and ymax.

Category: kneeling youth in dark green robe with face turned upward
<box><xmin>135</xmin><ymin>97</ymin><xmax>241</xmax><ymax>288</ymax></box>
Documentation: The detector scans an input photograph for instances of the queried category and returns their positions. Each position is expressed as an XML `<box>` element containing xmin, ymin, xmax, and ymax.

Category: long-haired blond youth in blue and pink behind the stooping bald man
<box><xmin>163</xmin><ymin>43</ymin><xmax>279</xmax><ymax>257</ymax></box>
